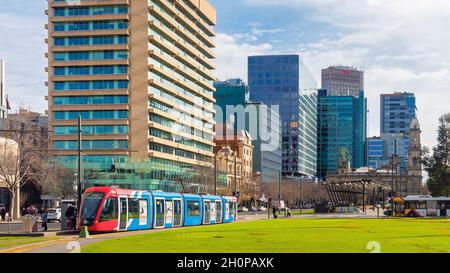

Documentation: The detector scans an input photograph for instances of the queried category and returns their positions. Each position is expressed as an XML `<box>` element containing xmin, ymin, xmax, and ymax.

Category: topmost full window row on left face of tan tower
<box><xmin>53</xmin><ymin>5</ymin><xmax>128</xmax><ymax>16</ymax></box>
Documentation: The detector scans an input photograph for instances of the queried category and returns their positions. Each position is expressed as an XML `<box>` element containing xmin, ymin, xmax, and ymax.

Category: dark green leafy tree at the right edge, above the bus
<box><xmin>422</xmin><ymin>113</ymin><xmax>450</xmax><ymax>196</ymax></box>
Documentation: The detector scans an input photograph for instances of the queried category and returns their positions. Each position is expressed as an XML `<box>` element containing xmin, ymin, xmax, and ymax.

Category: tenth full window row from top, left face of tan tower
<box><xmin>53</xmin><ymin>140</ymin><xmax>128</xmax><ymax>150</ymax></box>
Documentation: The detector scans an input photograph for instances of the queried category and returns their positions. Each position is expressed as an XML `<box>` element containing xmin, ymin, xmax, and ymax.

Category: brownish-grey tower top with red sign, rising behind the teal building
<box><xmin>322</xmin><ymin>66</ymin><xmax>364</xmax><ymax>97</ymax></box>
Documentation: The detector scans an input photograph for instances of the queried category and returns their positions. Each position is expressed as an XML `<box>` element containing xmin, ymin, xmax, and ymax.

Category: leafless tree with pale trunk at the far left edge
<box><xmin>0</xmin><ymin>123</ymin><xmax>46</xmax><ymax>219</ymax></box>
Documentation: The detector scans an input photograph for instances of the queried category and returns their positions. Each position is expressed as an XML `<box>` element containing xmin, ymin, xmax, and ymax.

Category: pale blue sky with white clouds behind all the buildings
<box><xmin>0</xmin><ymin>0</ymin><xmax>450</xmax><ymax>150</ymax></box>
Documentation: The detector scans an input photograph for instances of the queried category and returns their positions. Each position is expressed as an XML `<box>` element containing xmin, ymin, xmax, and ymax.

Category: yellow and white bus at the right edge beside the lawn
<box><xmin>394</xmin><ymin>195</ymin><xmax>450</xmax><ymax>217</ymax></box>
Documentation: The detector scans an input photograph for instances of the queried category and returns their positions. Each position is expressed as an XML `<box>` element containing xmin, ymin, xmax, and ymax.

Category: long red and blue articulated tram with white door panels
<box><xmin>78</xmin><ymin>187</ymin><xmax>237</xmax><ymax>233</ymax></box>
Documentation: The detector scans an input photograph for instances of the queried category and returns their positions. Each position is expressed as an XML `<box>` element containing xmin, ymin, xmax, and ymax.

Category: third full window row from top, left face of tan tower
<box><xmin>53</xmin><ymin>35</ymin><xmax>128</xmax><ymax>46</ymax></box>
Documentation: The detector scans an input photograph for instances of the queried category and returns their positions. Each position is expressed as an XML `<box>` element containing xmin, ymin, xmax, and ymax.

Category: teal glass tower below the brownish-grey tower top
<box><xmin>317</xmin><ymin>90</ymin><xmax>367</xmax><ymax>179</ymax></box>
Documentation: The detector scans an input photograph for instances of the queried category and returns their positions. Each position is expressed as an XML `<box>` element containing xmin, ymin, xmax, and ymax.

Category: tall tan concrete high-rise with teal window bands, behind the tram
<box><xmin>47</xmin><ymin>0</ymin><xmax>216</xmax><ymax>190</ymax></box>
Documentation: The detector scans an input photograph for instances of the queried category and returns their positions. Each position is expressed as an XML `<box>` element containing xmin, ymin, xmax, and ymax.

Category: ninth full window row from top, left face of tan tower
<box><xmin>53</xmin><ymin>125</ymin><xmax>129</xmax><ymax>135</ymax></box>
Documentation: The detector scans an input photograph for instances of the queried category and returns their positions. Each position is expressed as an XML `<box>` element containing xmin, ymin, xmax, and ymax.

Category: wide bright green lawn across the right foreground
<box><xmin>82</xmin><ymin>219</ymin><xmax>450</xmax><ymax>253</ymax></box>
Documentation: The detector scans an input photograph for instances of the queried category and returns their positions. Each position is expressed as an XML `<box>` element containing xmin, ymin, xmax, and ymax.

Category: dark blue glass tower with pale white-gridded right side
<box><xmin>248</xmin><ymin>55</ymin><xmax>317</xmax><ymax>177</ymax></box>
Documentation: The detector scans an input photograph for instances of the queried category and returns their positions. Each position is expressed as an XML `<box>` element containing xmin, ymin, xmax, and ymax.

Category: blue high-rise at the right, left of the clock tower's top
<box><xmin>380</xmin><ymin>92</ymin><xmax>416</xmax><ymax>135</ymax></box>
